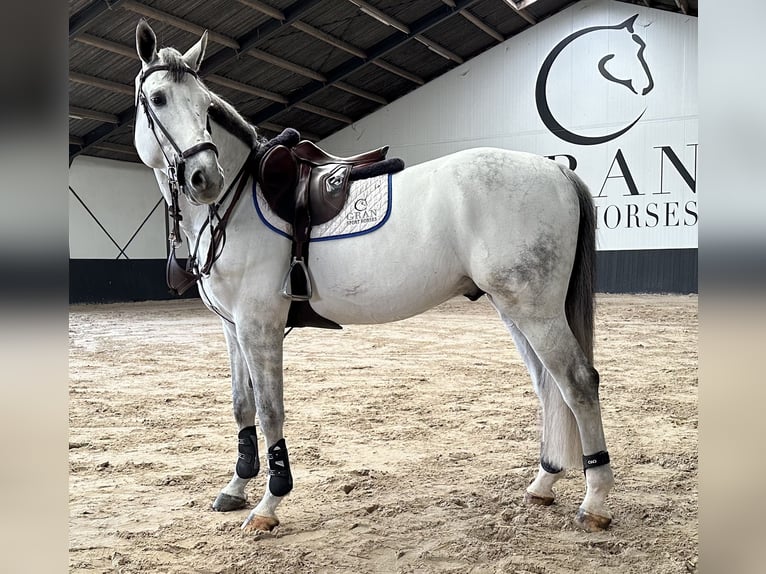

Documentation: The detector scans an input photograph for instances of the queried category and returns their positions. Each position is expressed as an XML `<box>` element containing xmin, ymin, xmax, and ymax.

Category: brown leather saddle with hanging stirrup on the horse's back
<box><xmin>258</xmin><ymin>130</ymin><xmax>404</xmax><ymax>328</ymax></box>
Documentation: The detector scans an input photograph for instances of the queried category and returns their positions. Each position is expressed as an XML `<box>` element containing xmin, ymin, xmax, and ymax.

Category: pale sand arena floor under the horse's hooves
<box><xmin>69</xmin><ymin>295</ymin><xmax>698</xmax><ymax>574</ymax></box>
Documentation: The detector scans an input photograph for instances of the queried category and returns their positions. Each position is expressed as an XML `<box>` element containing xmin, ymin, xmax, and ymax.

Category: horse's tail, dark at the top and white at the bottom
<box><xmin>538</xmin><ymin>167</ymin><xmax>596</xmax><ymax>469</ymax></box>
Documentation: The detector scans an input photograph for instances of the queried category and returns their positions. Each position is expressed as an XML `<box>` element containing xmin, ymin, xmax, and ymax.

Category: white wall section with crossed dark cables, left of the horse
<box><xmin>69</xmin><ymin>156</ymin><xmax>167</xmax><ymax>259</ymax></box>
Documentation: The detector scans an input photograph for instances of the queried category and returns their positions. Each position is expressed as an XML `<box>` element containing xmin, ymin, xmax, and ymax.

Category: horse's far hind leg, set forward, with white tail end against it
<box><xmin>501</xmin><ymin>314</ymin><xmax>582</xmax><ymax>506</ymax></box>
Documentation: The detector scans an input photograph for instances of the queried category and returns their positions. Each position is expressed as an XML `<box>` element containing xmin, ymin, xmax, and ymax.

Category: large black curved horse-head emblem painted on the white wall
<box><xmin>535</xmin><ymin>14</ymin><xmax>654</xmax><ymax>145</ymax></box>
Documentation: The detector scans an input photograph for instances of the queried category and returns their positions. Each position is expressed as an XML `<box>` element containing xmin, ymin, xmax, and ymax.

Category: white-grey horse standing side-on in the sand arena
<box><xmin>130</xmin><ymin>21</ymin><xmax>614</xmax><ymax>531</ymax></box>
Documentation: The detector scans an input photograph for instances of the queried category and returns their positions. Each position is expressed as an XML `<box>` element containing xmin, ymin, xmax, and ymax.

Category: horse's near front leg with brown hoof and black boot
<box><xmin>238</xmin><ymin>324</ymin><xmax>293</xmax><ymax>532</ymax></box>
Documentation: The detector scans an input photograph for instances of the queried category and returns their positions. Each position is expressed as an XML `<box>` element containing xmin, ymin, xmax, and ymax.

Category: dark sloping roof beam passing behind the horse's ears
<box><xmin>69</xmin><ymin>0</ymin><xmax>322</xmax><ymax>164</ymax></box>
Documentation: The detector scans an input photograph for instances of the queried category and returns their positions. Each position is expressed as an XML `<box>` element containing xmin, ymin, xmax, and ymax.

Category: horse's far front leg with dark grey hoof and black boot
<box><xmin>213</xmin><ymin>323</ymin><xmax>260</xmax><ymax>512</ymax></box>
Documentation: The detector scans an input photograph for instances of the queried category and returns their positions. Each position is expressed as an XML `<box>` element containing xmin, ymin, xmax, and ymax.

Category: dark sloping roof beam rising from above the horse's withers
<box><xmin>253</xmin><ymin>0</ymin><xmax>479</xmax><ymax>125</ymax></box>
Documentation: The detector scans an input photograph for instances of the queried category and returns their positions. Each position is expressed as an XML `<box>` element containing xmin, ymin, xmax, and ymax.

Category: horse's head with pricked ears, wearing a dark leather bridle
<box><xmin>134</xmin><ymin>20</ymin><xmax>224</xmax><ymax>204</ymax></box>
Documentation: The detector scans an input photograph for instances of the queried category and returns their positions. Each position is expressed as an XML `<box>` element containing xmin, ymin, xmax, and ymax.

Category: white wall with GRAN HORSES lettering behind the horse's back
<box><xmin>321</xmin><ymin>0</ymin><xmax>698</xmax><ymax>250</ymax></box>
